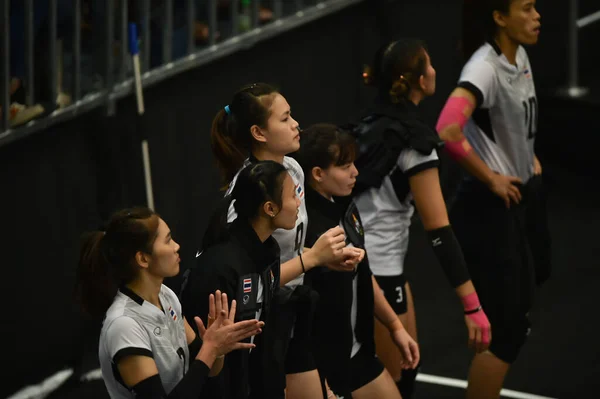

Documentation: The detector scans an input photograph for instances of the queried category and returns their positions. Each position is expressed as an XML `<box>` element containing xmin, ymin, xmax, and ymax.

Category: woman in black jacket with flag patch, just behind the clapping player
<box><xmin>181</xmin><ymin>161</ymin><xmax>299</xmax><ymax>399</ymax></box>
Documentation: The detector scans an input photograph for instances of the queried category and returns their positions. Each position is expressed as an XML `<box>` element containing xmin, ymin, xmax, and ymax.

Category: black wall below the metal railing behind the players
<box><xmin>0</xmin><ymin>0</ymin><xmax>597</xmax><ymax>396</ymax></box>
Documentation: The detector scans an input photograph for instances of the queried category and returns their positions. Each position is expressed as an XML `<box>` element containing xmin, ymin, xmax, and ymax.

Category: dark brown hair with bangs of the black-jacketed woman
<box><xmin>291</xmin><ymin>123</ymin><xmax>356</xmax><ymax>182</ymax></box>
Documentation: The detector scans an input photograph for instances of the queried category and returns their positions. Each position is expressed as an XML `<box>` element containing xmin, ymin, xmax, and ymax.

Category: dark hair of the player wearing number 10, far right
<box><xmin>461</xmin><ymin>0</ymin><xmax>512</xmax><ymax>62</ymax></box>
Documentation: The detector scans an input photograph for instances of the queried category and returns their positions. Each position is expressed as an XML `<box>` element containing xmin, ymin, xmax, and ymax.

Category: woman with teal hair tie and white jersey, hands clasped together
<box><xmin>211</xmin><ymin>83</ymin><xmax>359</xmax><ymax>399</ymax></box>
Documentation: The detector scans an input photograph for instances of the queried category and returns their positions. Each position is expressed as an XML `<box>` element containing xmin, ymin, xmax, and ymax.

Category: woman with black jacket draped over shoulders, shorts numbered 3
<box><xmin>355</xmin><ymin>39</ymin><xmax>490</xmax><ymax>399</ymax></box>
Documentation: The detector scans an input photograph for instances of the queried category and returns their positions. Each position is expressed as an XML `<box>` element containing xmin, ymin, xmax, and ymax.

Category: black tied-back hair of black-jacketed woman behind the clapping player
<box><xmin>202</xmin><ymin>161</ymin><xmax>287</xmax><ymax>251</ymax></box>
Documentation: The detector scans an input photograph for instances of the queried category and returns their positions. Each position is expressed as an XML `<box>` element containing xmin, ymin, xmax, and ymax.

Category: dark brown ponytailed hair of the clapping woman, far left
<box><xmin>75</xmin><ymin>207</ymin><xmax>159</xmax><ymax>318</ymax></box>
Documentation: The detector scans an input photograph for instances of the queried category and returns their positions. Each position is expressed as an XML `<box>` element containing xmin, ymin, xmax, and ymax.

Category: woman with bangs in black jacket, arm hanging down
<box><xmin>294</xmin><ymin>124</ymin><xmax>419</xmax><ymax>399</ymax></box>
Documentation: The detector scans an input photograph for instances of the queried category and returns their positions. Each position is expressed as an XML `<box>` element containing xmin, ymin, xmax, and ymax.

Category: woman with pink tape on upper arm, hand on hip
<box><xmin>437</xmin><ymin>0</ymin><xmax>549</xmax><ymax>398</ymax></box>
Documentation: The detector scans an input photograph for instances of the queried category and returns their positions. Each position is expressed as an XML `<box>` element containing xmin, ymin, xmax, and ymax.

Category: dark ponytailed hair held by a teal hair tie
<box><xmin>210</xmin><ymin>83</ymin><xmax>278</xmax><ymax>184</ymax></box>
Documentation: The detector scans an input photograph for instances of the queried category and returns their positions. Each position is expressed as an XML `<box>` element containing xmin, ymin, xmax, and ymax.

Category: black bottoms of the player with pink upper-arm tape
<box><xmin>450</xmin><ymin>182</ymin><xmax>535</xmax><ymax>363</ymax></box>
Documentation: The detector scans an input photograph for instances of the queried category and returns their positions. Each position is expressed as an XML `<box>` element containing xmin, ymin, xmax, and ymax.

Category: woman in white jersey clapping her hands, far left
<box><xmin>77</xmin><ymin>208</ymin><xmax>264</xmax><ymax>399</ymax></box>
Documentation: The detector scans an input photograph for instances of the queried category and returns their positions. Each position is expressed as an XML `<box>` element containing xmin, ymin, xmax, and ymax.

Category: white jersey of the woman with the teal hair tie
<box><xmin>225</xmin><ymin>157</ymin><xmax>308</xmax><ymax>287</ymax></box>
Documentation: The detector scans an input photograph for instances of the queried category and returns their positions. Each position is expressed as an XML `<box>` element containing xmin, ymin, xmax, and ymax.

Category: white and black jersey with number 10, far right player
<box><xmin>458</xmin><ymin>43</ymin><xmax>538</xmax><ymax>182</ymax></box>
